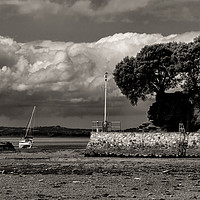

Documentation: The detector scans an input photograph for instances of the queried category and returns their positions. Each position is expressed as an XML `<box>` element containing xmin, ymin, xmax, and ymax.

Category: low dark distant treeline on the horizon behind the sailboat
<box><xmin>0</xmin><ymin>126</ymin><xmax>92</xmax><ymax>137</ymax></box>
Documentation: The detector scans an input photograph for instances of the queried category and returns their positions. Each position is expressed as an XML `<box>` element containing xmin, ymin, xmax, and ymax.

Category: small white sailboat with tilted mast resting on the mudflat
<box><xmin>19</xmin><ymin>106</ymin><xmax>36</xmax><ymax>149</ymax></box>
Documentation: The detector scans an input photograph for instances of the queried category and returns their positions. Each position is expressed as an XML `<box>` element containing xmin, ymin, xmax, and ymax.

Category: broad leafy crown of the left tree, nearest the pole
<box><xmin>113</xmin><ymin>43</ymin><xmax>179</xmax><ymax>105</ymax></box>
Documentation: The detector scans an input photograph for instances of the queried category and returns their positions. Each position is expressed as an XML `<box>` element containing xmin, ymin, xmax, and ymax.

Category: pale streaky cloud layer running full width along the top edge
<box><xmin>0</xmin><ymin>0</ymin><xmax>200</xmax><ymax>22</ymax></box>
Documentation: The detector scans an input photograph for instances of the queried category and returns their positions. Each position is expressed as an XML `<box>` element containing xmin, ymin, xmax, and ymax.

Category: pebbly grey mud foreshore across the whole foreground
<box><xmin>0</xmin><ymin>148</ymin><xmax>200</xmax><ymax>200</ymax></box>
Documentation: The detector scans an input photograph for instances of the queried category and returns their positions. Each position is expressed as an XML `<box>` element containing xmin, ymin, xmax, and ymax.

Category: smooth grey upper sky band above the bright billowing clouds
<box><xmin>0</xmin><ymin>0</ymin><xmax>200</xmax><ymax>42</ymax></box>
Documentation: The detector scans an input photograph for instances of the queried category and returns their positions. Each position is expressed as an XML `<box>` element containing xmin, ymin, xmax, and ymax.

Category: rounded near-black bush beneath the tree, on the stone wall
<box><xmin>148</xmin><ymin>91</ymin><xmax>196</xmax><ymax>131</ymax></box>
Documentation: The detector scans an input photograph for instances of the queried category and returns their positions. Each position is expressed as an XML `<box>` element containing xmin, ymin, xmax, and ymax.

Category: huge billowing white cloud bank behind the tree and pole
<box><xmin>0</xmin><ymin>32</ymin><xmax>200</xmax><ymax>126</ymax></box>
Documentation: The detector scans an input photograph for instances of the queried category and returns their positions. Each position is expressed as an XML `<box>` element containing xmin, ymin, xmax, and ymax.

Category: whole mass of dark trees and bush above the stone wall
<box><xmin>113</xmin><ymin>37</ymin><xmax>200</xmax><ymax>131</ymax></box>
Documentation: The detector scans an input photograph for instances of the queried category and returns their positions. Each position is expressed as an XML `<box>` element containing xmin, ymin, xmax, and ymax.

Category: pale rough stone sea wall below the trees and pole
<box><xmin>85</xmin><ymin>132</ymin><xmax>200</xmax><ymax>157</ymax></box>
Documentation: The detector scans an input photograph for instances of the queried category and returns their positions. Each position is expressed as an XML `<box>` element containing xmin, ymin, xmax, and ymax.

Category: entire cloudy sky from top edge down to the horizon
<box><xmin>0</xmin><ymin>0</ymin><xmax>200</xmax><ymax>129</ymax></box>
